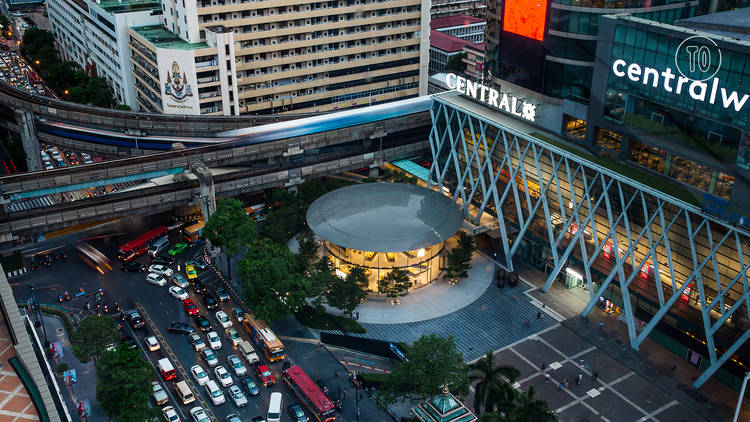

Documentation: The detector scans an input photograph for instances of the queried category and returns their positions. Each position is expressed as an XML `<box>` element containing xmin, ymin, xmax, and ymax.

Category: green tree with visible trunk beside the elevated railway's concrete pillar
<box><xmin>203</xmin><ymin>198</ymin><xmax>255</xmax><ymax>279</ymax></box>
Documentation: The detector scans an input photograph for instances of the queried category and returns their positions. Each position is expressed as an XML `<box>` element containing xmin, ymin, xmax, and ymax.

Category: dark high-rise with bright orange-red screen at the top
<box><xmin>486</xmin><ymin>0</ymin><xmax>698</xmax><ymax>102</ymax></box>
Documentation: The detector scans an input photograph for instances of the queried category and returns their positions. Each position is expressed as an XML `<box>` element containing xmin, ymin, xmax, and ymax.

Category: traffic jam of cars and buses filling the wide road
<box><xmin>22</xmin><ymin>221</ymin><xmax>341</xmax><ymax>422</ymax></box>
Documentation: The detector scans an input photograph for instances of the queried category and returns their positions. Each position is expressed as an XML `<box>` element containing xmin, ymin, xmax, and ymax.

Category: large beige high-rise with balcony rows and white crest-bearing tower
<box><xmin>128</xmin><ymin>0</ymin><xmax>430</xmax><ymax>115</ymax></box>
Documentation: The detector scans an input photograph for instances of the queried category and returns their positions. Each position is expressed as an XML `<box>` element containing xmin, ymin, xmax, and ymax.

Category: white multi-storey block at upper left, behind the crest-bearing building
<box><xmin>47</xmin><ymin>0</ymin><xmax>162</xmax><ymax>108</ymax></box>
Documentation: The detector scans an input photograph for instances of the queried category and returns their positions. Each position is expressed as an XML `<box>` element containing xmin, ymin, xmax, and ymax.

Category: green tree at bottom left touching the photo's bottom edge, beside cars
<box><xmin>95</xmin><ymin>342</ymin><xmax>160</xmax><ymax>422</ymax></box>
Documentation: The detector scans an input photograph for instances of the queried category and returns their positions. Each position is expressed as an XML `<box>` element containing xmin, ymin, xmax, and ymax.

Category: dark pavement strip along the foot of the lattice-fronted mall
<box><xmin>518</xmin><ymin>264</ymin><xmax>750</xmax><ymax>421</ymax></box>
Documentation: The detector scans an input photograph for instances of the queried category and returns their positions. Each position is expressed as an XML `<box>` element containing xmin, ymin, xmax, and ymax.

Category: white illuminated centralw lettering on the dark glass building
<box><xmin>612</xmin><ymin>59</ymin><xmax>750</xmax><ymax>111</ymax></box>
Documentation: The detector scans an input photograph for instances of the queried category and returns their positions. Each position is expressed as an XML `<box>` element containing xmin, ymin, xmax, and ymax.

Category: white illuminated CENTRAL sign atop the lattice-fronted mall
<box><xmin>445</xmin><ymin>73</ymin><xmax>538</xmax><ymax>122</ymax></box>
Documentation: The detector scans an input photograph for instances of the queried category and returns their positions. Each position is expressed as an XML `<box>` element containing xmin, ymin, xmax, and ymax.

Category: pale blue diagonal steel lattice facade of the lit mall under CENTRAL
<box><xmin>428</xmin><ymin>96</ymin><xmax>750</xmax><ymax>388</ymax></box>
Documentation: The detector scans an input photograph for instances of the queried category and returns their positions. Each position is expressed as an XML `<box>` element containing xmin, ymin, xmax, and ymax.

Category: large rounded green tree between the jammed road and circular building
<box><xmin>239</xmin><ymin>239</ymin><xmax>310</xmax><ymax>322</ymax></box>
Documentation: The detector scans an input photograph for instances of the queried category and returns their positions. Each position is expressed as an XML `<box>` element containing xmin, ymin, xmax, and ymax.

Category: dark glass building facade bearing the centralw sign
<box><xmin>586</xmin><ymin>9</ymin><xmax>750</xmax><ymax>210</ymax></box>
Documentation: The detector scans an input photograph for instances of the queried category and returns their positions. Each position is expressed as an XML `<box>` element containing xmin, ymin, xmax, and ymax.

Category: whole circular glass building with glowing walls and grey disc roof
<box><xmin>307</xmin><ymin>183</ymin><xmax>463</xmax><ymax>291</ymax></box>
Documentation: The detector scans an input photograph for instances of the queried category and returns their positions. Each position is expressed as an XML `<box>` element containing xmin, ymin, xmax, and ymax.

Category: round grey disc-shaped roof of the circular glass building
<box><xmin>307</xmin><ymin>183</ymin><xmax>463</xmax><ymax>252</ymax></box>
